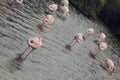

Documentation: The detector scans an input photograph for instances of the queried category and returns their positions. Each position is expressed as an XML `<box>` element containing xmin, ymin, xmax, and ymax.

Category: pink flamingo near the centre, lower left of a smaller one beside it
<box><xmin>65</xmin><ymin>33</ymin><xmax>83</xmax><ymax>50</ymax></box>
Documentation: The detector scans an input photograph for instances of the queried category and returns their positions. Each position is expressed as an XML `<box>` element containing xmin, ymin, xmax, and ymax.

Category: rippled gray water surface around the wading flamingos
<box><xmin>0</xmin><ymin>0</ymin><xmax>120</xmax><ymax>80</ymax></box>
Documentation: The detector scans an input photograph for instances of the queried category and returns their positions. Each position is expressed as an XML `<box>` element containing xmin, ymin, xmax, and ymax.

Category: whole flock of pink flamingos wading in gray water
<box><xmin>3</xmin><ymin>0</ymin><xmax>120</xmax><ymax>75</ymax></box>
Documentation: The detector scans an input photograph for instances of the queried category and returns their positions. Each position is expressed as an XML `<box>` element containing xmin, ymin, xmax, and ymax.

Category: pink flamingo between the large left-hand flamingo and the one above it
<box><xmin>37</xmin><ymin>15</ymin><xmax>54</xmax><ymax>31</ymax></box>
